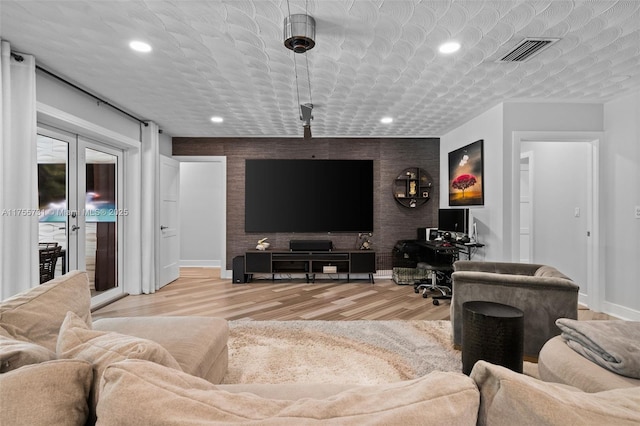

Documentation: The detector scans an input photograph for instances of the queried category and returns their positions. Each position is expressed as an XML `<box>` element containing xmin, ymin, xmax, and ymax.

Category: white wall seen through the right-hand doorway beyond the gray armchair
<box><xmin>521</xmin><ymin>142</ymin><xmax>591</xmax><ymax>295</ymax></box>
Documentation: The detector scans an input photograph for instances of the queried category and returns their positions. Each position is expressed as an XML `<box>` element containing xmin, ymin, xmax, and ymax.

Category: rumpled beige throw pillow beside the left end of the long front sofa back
<box><xmin>56</xmin><ymin>312</ymin><xmax>182</xmax><ymax>420</ymax></box>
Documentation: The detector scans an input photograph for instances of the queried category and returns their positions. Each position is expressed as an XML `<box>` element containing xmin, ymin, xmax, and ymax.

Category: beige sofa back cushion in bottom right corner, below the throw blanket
<box><xmin>471</xmin><ymin>361</ymin><xmax>640</xmax><ymax>426</ymax></box>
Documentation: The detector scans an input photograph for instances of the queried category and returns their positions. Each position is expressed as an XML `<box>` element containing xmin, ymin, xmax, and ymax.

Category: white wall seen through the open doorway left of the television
<box><xmin>180</xmin><ymin>162</ymin><xmax>226</xmax><ymax>267</ymax></box>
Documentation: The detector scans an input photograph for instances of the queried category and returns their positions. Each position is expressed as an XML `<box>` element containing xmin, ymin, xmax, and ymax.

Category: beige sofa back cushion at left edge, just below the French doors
<box><xmin>0</xmin><ymin>271</ymin><xmax>91</xmax><ymax>351</ymax></box>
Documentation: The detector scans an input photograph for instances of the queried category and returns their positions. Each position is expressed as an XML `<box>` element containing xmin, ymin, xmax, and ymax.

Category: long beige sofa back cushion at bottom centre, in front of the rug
<box><xmin>98</xmin><ymin>360</ymin><xmax>479</xmax><ymax>426</ymax></box>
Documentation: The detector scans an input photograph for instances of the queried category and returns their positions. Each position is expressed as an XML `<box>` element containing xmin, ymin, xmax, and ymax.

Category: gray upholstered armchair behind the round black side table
<box><xmin>451</xmin><ymin>260</ymin><xmax>579</xmax><ymax>360</ymax></box>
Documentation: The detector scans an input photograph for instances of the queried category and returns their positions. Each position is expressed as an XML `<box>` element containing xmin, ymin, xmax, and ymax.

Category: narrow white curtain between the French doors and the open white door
<box><xmin>140</xmin><ymin>122</ymin><xmax>160</xmax><ymax>294</ymax></box>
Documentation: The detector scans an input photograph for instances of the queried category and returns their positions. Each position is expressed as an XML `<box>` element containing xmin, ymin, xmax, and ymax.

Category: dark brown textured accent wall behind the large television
<box><xmin>173</xmin><ymin>137</ymin><xmax>440</xmax><ymax>269</ymax></box>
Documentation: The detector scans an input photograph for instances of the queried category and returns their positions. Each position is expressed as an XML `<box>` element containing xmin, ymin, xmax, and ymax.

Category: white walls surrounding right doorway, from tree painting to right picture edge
<box><xmin>440</xmin><ymin>99</ymin><xmax>640</xmax><ymax>320</ymax></box>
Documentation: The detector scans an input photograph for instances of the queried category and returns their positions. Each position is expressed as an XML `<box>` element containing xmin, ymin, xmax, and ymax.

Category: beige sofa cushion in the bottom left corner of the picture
<box><xmin>0</xmin><ymin>360</ymin><xmax>93</xmax><ymax>426</ymax></box>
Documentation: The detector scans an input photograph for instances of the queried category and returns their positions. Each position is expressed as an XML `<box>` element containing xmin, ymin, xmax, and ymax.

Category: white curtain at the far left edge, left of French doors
<box><xmin>0</xmin><ymin>41</ymin><xmax>39</xmax><ymax>300</ymax></box>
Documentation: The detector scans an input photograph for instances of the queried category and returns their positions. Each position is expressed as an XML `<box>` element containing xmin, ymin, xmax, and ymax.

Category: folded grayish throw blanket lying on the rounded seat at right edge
<box><xmin>556</xmin><ymin>318</ymin><xmax>640</xmax><ymax>379</ymax></box>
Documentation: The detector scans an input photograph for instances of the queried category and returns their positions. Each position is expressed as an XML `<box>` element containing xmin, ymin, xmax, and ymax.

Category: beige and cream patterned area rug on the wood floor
<box><xmin>223</xmin><ymin>320</ymin><xmax>462</xmax><ymax>384</ymax></box>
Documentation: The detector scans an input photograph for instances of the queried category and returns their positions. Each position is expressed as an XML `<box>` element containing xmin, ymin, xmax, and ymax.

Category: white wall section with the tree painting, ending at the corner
<box><xmin>440</xmin><ymin>104</ymin><xmax>505</xmax><ymax>260</ymax></box>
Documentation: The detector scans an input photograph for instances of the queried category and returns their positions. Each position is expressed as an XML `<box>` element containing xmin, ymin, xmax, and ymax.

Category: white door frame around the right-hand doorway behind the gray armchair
<box><xmin>511</xmin><ymin>131</ymin><xmax>604</xmax><ymax>311</ymax></box>
